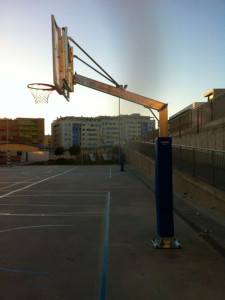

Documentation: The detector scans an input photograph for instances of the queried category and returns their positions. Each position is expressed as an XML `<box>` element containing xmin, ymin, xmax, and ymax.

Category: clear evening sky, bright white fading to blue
<box><xmin>0</xmin><ymin>0</ymin><xmax>225</xmax><ymax>134</ymax></box>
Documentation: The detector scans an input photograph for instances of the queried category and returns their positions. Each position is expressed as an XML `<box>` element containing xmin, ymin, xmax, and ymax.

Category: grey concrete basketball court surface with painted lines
<box><xmin>0</xmin><ymin>166</ymin><xmax>225</xmax><ymax>300</ymax></box>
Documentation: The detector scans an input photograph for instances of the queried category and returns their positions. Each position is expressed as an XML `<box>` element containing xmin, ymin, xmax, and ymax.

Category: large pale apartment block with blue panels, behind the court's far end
<box><xmin>52</xmin><ymin>114</ymin><xmax>155</xmax><ymax>149</ymax></box>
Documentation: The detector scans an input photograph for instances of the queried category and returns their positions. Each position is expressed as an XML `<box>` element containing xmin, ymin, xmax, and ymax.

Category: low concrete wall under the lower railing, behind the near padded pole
<box><xmin>125</xmin><ymin>147</ymin><xmax>225</xmax><ymax>212</ymax></box>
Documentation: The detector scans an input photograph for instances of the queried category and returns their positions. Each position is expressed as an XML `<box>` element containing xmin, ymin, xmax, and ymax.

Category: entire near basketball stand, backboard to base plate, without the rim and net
<box><xmin>46</xmin><ymin>15</ymin><xmax>181</xmax><ymax>248</ymax></box>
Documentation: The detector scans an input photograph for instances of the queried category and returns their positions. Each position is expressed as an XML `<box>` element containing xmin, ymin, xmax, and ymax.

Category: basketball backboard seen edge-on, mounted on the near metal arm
<box><xmin>51</xmin><ymin>15</ymin><xmax>74</xmax><ymax>101</ymax></box>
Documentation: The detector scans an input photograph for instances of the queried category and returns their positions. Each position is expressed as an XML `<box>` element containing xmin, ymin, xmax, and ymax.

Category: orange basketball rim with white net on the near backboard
<box><xmin>27</xmin><ymin>83</ymin><xmax>56</xmax><ymax>104</ymax></box>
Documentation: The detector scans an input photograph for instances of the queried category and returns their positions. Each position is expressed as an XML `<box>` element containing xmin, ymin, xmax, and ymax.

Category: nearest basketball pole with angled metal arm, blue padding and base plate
<box><xmin>74</xmin><ymin>73</ymin><xmax>181</xmax><ymax>249</ymax></box>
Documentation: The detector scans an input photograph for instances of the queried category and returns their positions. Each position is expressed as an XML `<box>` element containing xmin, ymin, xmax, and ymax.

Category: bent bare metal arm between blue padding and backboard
<box><xmin>73</xmin><ymin>73</ymin><xmax>168</xmax><ymax>137</ymax></box>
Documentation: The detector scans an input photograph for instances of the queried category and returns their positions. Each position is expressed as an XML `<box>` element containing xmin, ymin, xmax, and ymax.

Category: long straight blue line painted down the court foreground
<box><xmin>100</xmin><ymin>192</ymin><xmax>110</xmax><ymax>300</ymax></box>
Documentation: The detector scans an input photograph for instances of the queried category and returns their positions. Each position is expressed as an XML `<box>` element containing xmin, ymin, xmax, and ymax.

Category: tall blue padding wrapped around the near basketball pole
<box><xmin>155</xmin><ymin>137</ymin><xmax>174</xmax><ymax>237</ymax></box>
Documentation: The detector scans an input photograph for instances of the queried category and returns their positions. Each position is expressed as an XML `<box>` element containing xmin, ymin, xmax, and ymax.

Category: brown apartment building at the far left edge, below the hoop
<box><xmin>0</xmin><ymin>118</ymin><xmax>44</xmax><ymax>145</ymax></box>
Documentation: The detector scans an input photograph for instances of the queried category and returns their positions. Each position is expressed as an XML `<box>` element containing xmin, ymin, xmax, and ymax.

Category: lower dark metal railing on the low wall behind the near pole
<box><xmin>129</xmin><ymin>141</ymin><xmax>225</xmax><ymax>190</ymax></box>
